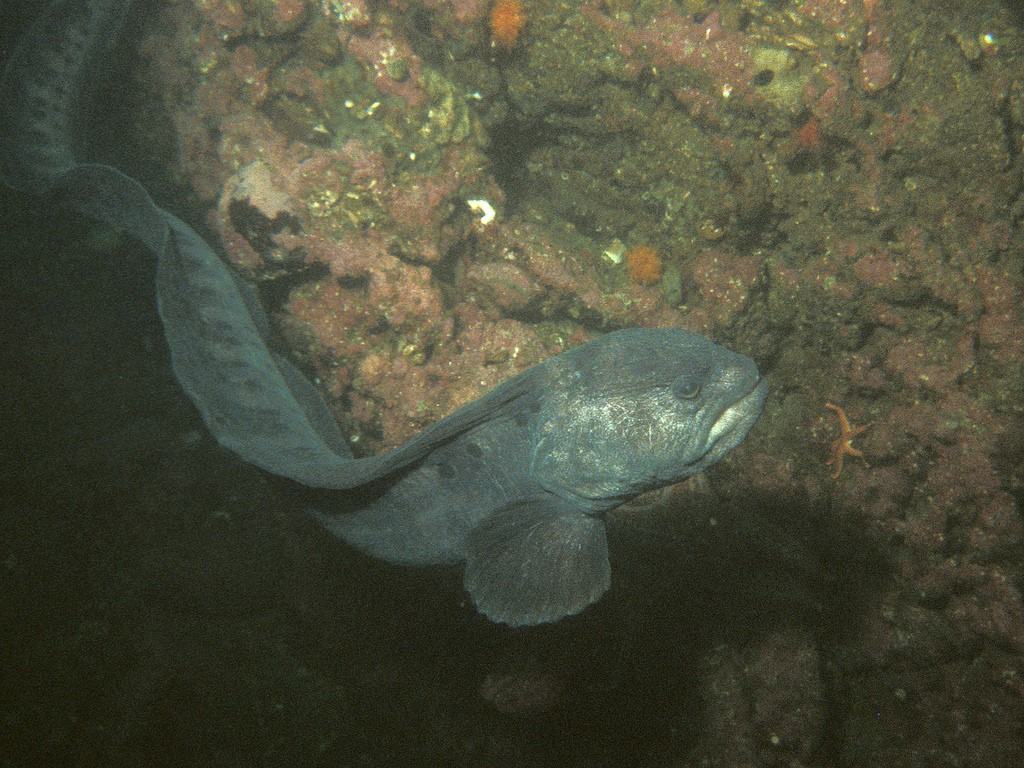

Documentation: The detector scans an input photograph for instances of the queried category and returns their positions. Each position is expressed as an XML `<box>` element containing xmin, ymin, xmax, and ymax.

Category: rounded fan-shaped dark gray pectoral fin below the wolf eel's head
<box><xmin>463</xmin><ymin>497</ymin><xmax>611</xmax><ymax>627</ymax></box>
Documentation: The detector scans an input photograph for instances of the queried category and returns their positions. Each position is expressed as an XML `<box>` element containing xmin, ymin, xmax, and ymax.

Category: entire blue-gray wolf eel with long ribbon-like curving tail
<box><xmin>0</xmin><ymin>0</ymin><xmax>766</xmax><ymax>626</ymax></box>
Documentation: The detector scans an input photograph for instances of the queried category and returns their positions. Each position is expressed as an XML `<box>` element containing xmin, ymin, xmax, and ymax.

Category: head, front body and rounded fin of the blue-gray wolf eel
<box><xmin>317</xmin><ymin>329</ymin><xmax>767</xmax><ymax>626</ymax></box>
